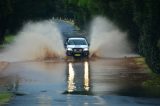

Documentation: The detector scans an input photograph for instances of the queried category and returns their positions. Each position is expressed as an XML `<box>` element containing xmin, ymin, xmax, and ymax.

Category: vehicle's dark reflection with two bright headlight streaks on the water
<box><xmin>65</xmin><ymin>61</ymin><xmax>91</xmax><ymax>95</ymax></box>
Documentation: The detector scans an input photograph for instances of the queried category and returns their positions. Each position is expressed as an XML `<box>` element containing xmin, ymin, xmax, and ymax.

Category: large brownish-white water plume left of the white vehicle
<box><xmin>0</xmin><ymin>21</ymin><xmax>65</xmax><ymax>61</ymax></box>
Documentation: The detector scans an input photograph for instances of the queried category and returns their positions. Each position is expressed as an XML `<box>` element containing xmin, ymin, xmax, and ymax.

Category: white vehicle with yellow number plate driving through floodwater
<box><xmin>65</xmin><ymin>37</ymin><xmax>89</xmax><ymax>57</ymax></box>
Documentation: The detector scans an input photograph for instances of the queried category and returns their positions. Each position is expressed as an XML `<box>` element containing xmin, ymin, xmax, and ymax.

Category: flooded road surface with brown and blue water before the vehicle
<box><xmin>0</xmin><ymin>58</ymin><xmax>160</xmax><ymax>106</ymax></box>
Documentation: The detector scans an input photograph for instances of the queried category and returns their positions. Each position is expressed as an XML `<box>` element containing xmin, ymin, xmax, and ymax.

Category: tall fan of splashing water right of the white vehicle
<box><xmin>90</xmin><ymin>17</ymin><xmax>130</xmax><ymax>57</ymax></box>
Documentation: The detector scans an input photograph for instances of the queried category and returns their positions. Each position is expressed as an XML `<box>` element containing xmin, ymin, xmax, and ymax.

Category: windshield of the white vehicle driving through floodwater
<box><xmin>68</xmin><ymin>39</ymin><xmax>87</xmax><ymax>45</ymax></box>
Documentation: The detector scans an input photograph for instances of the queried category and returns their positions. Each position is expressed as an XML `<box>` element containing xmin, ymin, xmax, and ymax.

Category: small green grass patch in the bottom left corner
<box><xmin>0</xmin><ymin>92</ymin><xmax>13</xmax><ymax>106</ymax></box>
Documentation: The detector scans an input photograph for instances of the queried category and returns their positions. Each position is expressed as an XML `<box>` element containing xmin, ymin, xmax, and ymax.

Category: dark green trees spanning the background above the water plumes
<box><xmin>0</xmin><ymin>0</ymin><xmax>160</xmax><ymax>72</ymax></box>
